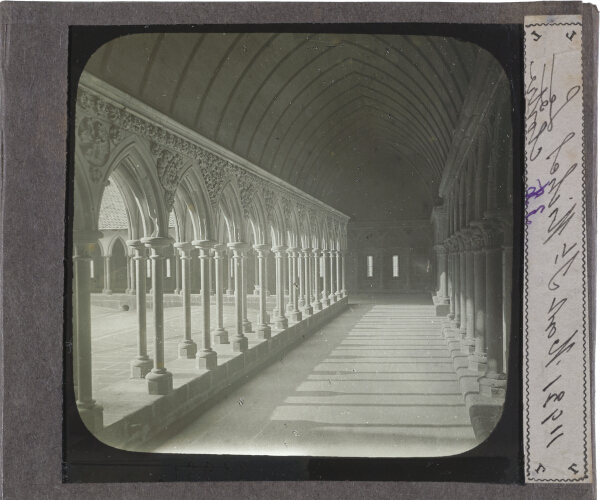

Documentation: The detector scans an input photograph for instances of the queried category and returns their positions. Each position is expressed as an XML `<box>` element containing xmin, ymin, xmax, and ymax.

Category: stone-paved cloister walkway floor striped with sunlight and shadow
<box><xmin>144</xmin><ymin>295</ymin><xmax>476</xmax><ymax>456</ymax></box>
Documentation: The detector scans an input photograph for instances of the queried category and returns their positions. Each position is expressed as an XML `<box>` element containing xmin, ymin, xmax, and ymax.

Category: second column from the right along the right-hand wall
<box><xmin>469</xmin><ymin>249</ymin><xmax>487</xmax><ymax>372</ymax></box>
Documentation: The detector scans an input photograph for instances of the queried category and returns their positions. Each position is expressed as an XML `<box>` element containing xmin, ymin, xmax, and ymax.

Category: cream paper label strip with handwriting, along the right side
<box><xmin>523</xmin><ymin>16</ymin><xmax>592</xmax><ymax>483</ymax></box>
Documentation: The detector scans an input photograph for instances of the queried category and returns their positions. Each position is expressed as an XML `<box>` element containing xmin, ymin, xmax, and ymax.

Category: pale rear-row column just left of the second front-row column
<box><xmin>127</xmin><ymin>240</ymin><xmax>154</xmax><ymax>378</ymax></box>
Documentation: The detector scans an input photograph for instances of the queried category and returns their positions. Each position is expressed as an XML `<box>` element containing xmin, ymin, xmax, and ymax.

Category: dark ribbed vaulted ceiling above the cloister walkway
<box><xmin>86</xmin><ymin>33</ymin><xmax>479</xmax><ymax>221</ymax></box>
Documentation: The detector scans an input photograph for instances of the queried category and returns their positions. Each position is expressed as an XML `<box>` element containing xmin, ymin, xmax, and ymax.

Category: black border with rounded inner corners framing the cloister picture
<box><xmin>63</xmin><ymin>23</ymin><xmax>524</xmax><ymax>484</ymax></box>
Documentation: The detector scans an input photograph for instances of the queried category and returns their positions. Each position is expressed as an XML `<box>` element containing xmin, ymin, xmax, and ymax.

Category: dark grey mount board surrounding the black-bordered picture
<box><xmin>0</xmin><ymin>2</ymin><xmax>598</xmax><ymax>500</ymax></box>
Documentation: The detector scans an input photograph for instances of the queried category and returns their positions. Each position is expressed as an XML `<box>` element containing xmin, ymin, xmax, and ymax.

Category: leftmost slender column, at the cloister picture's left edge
<box><xmin>73</xmin><ymin>231</ymin><xmax>103</xmax><ymax>432</ymax></box>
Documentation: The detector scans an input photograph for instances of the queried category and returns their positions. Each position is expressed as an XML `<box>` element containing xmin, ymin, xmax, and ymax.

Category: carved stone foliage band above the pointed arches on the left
<box><xmin>77</xmin><ymin>88</ymin><xmax>350</xmax><ymax>232</ymax></box>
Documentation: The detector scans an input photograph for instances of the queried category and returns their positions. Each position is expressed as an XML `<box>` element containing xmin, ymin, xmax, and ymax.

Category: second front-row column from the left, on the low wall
<box><xmin>141</xmin><ymin>237</ymin><xmax>173</xmax><ymax>394</ymax></box>
